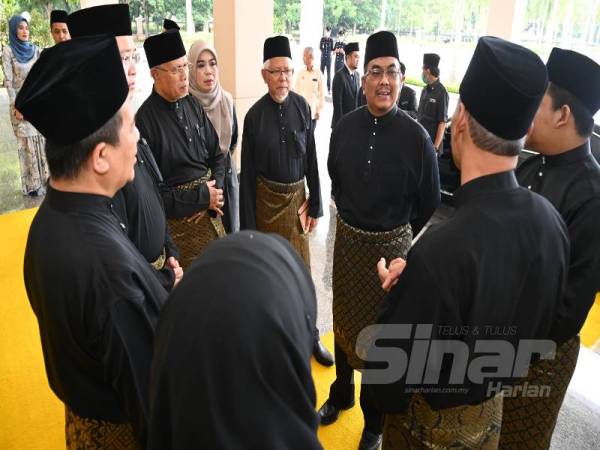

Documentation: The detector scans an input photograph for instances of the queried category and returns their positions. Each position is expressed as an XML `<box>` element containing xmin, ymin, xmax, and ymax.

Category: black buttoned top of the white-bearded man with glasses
<box><xmin>240</xmin><ymin>92</ymin><xmax>323</xmax><ymax>229</ymax></box>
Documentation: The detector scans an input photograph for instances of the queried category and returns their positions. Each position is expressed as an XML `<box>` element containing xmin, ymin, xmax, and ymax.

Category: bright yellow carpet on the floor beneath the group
<box><xmin>0</xmin><ymin>209</ymin><xmax>600</xmax><ymax>450</ymax></box>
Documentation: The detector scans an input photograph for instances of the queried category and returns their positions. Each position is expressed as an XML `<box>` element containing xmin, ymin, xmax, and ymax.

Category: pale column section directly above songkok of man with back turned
<box><xmin>487</xmin><ymin>0</ymin><xmax>527</xmax><ymax>42</ymax></box>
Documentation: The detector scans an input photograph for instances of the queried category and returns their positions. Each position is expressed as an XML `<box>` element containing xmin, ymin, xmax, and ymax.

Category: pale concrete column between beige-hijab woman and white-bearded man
<box><xmin>213</xmin><ymin>0</ymin><xmax>273</xmax><ymax>168</ymax></box>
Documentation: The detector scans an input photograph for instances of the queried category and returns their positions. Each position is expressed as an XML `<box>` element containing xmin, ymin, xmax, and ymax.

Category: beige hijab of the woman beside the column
<box><xmin>188</xmin><ymin>41</ymin><xmax>233</xmax><ymax>153</ymax></box>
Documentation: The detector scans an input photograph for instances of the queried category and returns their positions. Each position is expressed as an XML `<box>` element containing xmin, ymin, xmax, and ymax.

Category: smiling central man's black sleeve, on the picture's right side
<box><xmin>410</xmin><ymin>137</ymin><xmax>441</xmax><ymax>236</ymax></box>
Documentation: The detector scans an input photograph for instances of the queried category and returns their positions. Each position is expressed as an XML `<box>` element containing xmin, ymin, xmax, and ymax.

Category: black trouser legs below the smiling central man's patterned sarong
<box><xmin>329</xmin><ymin>342</ymin><xmax>384</xmax><ymax>434</ymax></box>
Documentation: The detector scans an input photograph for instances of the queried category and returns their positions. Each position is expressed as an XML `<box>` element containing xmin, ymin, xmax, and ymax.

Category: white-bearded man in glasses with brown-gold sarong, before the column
<box><xmin>240</xmin><ymin>36</ymin><xmax>333</xmax><ymax>366</ymax></box>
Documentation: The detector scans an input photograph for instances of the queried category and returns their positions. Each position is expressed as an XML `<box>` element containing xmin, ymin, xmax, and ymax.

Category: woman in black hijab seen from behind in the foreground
<box><xmin>148</xmin><ymin>231</ymin><xmax>321</xmax><ymax>450</ymax></box>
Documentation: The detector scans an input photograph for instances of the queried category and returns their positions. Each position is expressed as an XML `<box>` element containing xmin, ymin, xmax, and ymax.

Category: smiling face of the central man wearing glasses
<box><xmin>363</xmin><ymin>56</ymin><xmax>402</xmax><ymax>116</ymax></box>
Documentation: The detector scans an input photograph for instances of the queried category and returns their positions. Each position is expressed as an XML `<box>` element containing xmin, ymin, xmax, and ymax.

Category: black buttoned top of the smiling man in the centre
<box><xmin>327</xmin><ymin>105</ymin><xmax>440</xmax><ymax>236</ymax></box>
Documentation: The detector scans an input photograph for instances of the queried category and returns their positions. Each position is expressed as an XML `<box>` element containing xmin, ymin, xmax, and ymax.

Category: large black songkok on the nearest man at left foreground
<box><xmin>15</xmin><ymin>36</ymin><xmax>129</xmax><ymax>145</ymax></box>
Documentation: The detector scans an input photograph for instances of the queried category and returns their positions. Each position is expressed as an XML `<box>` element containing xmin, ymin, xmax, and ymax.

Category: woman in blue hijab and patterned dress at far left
<box><xmin>2</xmin><ymin>15</ymin><xmax>47</xmax><ymax>197</ymax></box>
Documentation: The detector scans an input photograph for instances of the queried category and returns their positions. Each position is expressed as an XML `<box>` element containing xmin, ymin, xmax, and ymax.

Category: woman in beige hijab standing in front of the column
<box><xmin>188</xmin><ymin>41</ymin><xmax>240</xmax><ymax>233</ymax></box>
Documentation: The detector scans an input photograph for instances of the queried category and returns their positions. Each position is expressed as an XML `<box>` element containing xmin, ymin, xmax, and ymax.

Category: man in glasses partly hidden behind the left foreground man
<box><xmin>67</xmin><ymin>4</ymin><xmax>183</xmax><ymax>290</ymax></box>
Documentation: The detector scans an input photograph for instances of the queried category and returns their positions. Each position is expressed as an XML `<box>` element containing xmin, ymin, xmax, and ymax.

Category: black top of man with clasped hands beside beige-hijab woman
<box><xmin>135</xmin><ymin>90</ymin><xmax>225</xmax><ymax>219</ymax></box>
